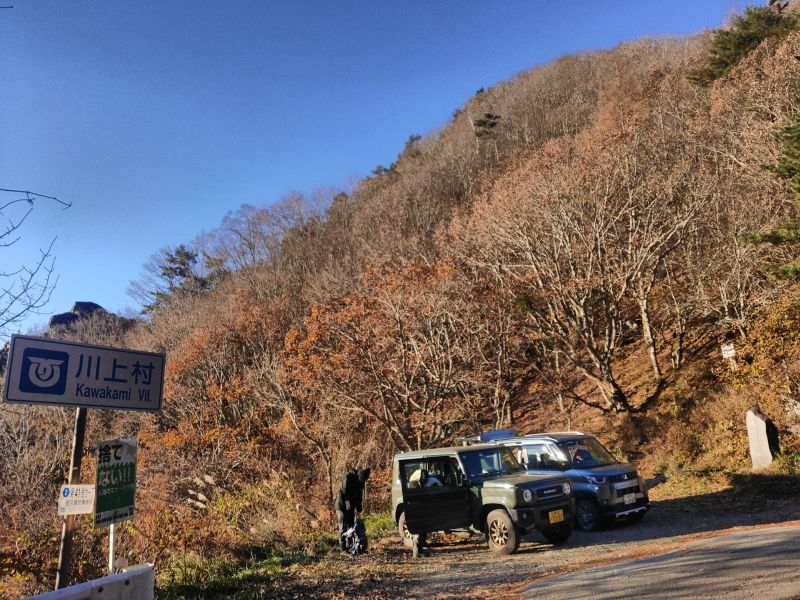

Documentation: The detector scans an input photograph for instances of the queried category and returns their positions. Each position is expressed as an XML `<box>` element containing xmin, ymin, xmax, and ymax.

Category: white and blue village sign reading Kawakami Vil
<box><xmin>3</xmin><ymin>335</ymin><xmax>164</xmax><ymax>412</ymax></box>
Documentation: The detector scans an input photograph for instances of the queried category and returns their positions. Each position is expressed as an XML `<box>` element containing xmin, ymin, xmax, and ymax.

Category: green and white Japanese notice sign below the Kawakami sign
<box><xmin>94</xmin><ymin>439</ymin><xmax>136</xmax><ymax>528</ymax></box>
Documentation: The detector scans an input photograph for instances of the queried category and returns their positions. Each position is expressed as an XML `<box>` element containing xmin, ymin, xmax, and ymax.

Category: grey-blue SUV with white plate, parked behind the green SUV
<box><xmin>478</xmin><ymin>431</ymin><xmax>650</xmax><ymax>531</ymax></box>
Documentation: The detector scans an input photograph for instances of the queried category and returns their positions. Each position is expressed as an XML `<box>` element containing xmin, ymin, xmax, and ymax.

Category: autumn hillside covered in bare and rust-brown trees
<box><xmin>0</xmin><ymin>8</ymin><xmax>800</xmax><ymax>595</ymax></box>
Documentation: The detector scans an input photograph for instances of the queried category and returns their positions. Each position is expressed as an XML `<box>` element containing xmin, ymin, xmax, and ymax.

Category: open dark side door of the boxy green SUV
<box><xmin>399</xmin><ymin>456</ymin><xmax>471</xmax><ymax>533</ymax></box>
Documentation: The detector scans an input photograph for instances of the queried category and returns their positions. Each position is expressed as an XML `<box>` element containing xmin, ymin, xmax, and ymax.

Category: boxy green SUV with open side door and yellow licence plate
<box><xmin>392</xmin><ymin>444</ymin><xmax>574</xmax><ymax>554</ymax></box>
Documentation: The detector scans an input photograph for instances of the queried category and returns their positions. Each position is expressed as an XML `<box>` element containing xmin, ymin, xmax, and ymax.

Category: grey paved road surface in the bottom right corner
<box><xmin>523</xmin><ymin>527</ymin><xmax>800</xmax><ymax>600</ymax></box>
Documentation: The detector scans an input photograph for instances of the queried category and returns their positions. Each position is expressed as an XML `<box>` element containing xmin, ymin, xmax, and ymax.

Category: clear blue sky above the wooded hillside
<box><xmin>0</xmin><ymin>0</ymin><xmax>764</xmax><ymax>332</ymax></box>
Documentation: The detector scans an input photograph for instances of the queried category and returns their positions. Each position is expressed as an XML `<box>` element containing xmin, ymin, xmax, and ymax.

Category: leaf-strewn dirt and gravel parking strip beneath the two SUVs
<box><xmin>274</xmin><ymin>481</ymin><xmax>800</xmax><ymax>600</ymax></box>
